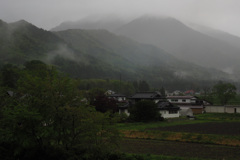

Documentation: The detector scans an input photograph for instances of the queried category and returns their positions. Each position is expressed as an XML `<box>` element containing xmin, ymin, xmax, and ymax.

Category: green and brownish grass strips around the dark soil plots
<box><xmin>116</xmin><ymin>113</ymin><xmax>240</xmax><ymax>160</ymax></box>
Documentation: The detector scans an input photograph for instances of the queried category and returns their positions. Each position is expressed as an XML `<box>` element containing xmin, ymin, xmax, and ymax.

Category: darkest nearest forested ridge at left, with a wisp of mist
<box><xmin>0</xmin><ymin>20</ymin><xmax>130</xmax><ymax>78</ymax></box>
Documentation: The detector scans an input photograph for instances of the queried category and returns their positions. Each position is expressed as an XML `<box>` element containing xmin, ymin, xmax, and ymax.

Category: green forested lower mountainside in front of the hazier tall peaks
<box><xmin>0</xmin><ymin>21</ymin><xmax>232</xmax><ymax>87</ymax></box>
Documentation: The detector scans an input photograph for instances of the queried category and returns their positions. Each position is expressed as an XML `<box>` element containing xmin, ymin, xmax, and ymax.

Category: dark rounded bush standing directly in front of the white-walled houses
<box><xmin>130</xmin><ymin>100</ymin><xmax>161</xmax><ymax>122</ymax></box>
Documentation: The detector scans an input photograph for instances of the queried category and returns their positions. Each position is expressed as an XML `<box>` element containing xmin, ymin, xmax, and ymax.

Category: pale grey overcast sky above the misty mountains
<box><xmin>0</xmin><ymin>0</ymin><xmax>240</xmax><ymax>36</ymax></box>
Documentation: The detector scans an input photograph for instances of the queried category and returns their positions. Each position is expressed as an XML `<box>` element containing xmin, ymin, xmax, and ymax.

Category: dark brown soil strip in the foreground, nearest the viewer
<box><xmin>121</xmin><ymin>139</ymin><xmax>240</xmax><ymax>160</ymax></box>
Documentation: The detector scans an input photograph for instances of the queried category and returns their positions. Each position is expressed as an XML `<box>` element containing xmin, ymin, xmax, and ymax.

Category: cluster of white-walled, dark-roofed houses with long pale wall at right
<box><xmin>107</xmin><ymin>92</ymin><xmax>240</xmax><ymax>118</ymax></box>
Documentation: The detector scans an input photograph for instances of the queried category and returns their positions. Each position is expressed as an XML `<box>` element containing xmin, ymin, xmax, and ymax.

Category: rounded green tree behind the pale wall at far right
<box><xmin>212</xmin><ymin>81</ymin><xmax>237</xmax><ymax>105</ymax></box>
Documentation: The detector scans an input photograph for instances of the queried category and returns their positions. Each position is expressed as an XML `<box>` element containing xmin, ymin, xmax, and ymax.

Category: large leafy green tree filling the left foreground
<box><xmin>0</xmin><ymin>63</ymin><xmax>118</xmax><ymax>159</ymax></box>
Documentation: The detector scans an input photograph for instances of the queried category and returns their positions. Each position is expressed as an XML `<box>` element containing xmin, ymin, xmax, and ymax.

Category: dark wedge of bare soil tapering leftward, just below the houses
<box><xmin>150</xmin><ymin>122</ymin><xmax>240</xmax><ymax>136</ymax></box>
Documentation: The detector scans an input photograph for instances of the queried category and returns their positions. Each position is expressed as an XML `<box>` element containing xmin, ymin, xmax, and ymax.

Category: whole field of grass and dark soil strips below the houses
<box><xmin>117</xmin><ymin>114</ymin><xmax>240</xmax><ymax>160</ymax></box>
